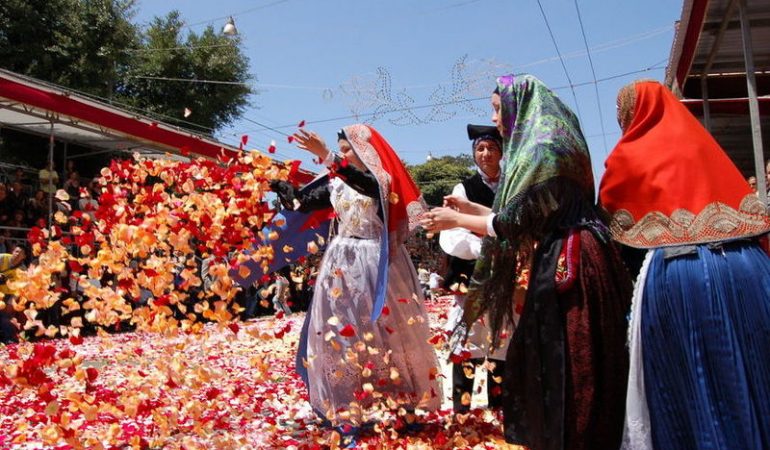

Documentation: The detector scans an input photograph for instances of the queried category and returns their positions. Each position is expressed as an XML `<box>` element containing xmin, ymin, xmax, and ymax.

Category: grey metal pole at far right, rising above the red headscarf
<box><xmin>738</xmin><ymin>0</ymin><xmax>767</xmax><ymax>205</ymax></box>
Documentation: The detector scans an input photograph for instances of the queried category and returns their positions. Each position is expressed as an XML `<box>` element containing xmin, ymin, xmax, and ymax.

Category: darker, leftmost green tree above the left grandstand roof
<box><xmin>0</xmin><ymin>0</ymin><xmax>138</xmax><ymax>97</ymax></box>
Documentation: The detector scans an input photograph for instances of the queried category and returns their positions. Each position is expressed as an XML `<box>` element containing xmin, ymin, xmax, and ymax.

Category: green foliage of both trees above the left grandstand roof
<box><xmin>0</xmin><ymin>0</ymin><xmax>251</xmax><ymax>133</ymax></box>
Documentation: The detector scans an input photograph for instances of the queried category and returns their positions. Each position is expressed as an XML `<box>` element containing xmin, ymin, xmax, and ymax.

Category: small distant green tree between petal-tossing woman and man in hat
<box><xmin>408</xmin><ymin>155</ymin><xmax>474</xmax><ymax>206</ymax></box>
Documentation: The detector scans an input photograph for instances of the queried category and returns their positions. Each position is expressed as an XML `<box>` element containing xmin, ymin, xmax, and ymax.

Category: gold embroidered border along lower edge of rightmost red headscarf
<box><xmin>610</xmin><ymin>194</ymin><xmax>770</xmax><ymax>248</ymax></box>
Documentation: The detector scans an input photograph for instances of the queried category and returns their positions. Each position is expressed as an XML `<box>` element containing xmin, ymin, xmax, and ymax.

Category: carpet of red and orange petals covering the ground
<box><xmin>0</xmin><ymin>297</ymin><xmax>516</xmax><ymax>449</ymax></box>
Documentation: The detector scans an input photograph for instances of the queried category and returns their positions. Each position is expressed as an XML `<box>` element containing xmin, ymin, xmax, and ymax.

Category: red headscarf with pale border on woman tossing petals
<box><xmin>343</xmin><ymin>124</ymin><xmax>427</xmax><ymax>243</ymax></box>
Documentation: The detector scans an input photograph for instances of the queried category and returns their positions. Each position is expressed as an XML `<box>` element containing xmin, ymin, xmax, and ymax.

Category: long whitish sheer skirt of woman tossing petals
<box><xmin>307</xmin><ymin>237</ymin><xmax>441</xmax><ymax>424</ymax></box>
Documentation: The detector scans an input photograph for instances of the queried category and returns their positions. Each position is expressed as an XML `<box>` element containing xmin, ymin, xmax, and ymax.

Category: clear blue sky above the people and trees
<box><xmin>136</xmin><ymin>0</ymin><xmax>681</xmax><ymax>185</ymax></box>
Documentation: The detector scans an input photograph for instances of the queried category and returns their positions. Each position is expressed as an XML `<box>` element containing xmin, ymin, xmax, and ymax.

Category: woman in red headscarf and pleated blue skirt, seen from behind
<box><xmin>600</xmin><ymin>81</ymin><xmax>770</xmax><ymax>450</ymax></box>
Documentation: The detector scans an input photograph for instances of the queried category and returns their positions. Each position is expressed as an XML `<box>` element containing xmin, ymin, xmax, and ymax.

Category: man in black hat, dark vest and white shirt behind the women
<box><xmin>439</xmin><ymin>125</ymin><xmax>508</xmax><ymax>413</ymax></box>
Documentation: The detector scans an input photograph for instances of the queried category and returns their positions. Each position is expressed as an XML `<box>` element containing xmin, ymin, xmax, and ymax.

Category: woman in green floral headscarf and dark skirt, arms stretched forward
<box><xmin>423</xmin><ymin>75</ymin><xmax>631</xmax><ymax>450</ymax></box>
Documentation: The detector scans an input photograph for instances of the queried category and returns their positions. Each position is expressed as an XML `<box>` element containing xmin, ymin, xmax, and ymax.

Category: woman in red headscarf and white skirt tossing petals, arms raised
<box><xmin>272</xmin><ymin>125</ymin><xmax>442</xmax><ymax>446</ymax></box>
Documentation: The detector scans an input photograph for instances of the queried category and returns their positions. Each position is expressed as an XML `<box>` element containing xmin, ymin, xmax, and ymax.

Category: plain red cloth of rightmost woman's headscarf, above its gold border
<box><xmin>599</xmin><ymin>82</ymin><xmax>751</xmax><ymax>221</ymax></box>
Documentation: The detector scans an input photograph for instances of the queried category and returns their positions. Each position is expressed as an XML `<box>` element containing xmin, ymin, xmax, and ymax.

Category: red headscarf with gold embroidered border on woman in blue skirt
<box><xmin>599</xmin><ymin>82</ymin><xmax>770</xmax><ymax>248</ymax></box>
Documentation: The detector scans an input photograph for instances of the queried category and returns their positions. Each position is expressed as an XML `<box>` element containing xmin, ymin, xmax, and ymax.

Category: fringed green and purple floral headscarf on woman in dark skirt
<box><xmin>465</xmin><ymin>74</ymin><xmax>594</xmax><ymax>342</ymax></box>
